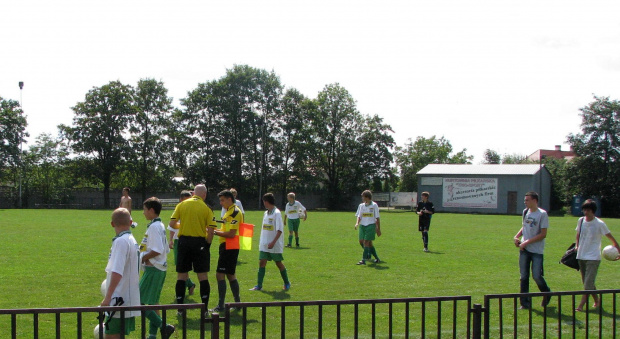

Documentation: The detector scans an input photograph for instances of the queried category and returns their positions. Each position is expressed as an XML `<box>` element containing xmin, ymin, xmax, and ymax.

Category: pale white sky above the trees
<box><xmin>0</xmin><ymin>0</ymin><xmax>620</xmax><ymax>163</ymax></box>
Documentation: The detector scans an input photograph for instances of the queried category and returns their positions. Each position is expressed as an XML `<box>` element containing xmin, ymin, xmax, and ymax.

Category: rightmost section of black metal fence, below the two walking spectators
<box><xmin>483</xmin><ymin>290</ymin><xmax>620</xmax><ymax>339</ymax></box>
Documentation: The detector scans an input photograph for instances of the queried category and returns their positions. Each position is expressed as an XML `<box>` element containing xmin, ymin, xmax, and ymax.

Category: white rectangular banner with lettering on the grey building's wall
<box><xmin>442</xmin><ymin>178</ymin><xmax>497</xmax><ymax>208</ymax></box>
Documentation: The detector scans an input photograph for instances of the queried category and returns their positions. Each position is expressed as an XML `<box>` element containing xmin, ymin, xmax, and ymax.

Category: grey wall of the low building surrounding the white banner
<box><xmin>417</xmin><ymin>173</ymin><xmax>551</xmax><ymax>214</ymax></box>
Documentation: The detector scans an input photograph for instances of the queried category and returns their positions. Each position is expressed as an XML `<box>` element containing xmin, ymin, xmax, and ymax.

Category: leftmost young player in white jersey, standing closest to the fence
<box><xmin>101</xmin><ymin>208</ymin><xmax>140</xmax><ymax>339</ymax></box>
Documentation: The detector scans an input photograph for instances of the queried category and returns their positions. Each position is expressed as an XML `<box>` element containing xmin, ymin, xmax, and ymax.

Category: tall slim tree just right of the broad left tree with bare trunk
<box><xmin>129</xmin><ymin>79</ymin><xmax>174</xmax><ymax>201</ymax></box>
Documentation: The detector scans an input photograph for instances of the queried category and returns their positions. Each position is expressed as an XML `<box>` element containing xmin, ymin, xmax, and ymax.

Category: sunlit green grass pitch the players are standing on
<box><xmin>0</xmin><ymin>210</ymin><xmax>620</xmax><ymax>338</ymax></box>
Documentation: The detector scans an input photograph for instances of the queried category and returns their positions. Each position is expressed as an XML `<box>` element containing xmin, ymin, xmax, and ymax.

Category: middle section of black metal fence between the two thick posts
<box><xmin>224</xmin><ymin>296</ymin><xmax>471</xmax><ymax>339</ymax></box>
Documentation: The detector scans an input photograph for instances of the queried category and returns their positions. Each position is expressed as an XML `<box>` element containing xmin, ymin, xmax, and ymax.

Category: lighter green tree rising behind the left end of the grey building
<box><xmin>395</xmin><ymin>135</ymin><xmax>473</xmax><ymax>192</ymax></box>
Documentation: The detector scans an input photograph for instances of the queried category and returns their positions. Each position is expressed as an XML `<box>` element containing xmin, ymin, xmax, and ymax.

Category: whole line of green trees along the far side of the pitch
<box><xmin>0</xmin><ymin>65</ymin><xmax>620</xmax><ymax>215</ymax></box>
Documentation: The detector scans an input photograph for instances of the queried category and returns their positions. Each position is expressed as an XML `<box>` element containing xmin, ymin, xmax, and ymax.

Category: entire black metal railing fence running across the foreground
<box><xmin>0</xmin><ymin>290</ymin><xmax>620</xmax><ymax>339</ymax></box>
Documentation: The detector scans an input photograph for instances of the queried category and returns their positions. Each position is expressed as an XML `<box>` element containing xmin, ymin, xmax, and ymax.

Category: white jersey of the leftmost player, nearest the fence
<box><xmin>105</xmin><ymin>231</ymin><xmax>140</xmax><ymax>318</ymax></box>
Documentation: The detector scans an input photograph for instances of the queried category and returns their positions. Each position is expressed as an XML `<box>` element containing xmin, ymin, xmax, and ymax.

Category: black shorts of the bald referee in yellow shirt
<box><xmin>177</xmin><ymin>235</ymin><xmax>211</xmax><ymax>273</ymax></box>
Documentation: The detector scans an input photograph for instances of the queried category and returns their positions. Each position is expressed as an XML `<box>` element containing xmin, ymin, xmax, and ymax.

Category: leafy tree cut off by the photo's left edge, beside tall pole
<box><xmin>0</xmin><ymin>97</ymin><xmax>28</xmax><ymax>179</ymax></box>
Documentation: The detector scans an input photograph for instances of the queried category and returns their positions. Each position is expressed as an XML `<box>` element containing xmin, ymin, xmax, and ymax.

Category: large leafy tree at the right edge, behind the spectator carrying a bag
<box><xmin>567</xmin><ymin>96</ymin><xmax>620</xmax><ymax>216</ymax></box>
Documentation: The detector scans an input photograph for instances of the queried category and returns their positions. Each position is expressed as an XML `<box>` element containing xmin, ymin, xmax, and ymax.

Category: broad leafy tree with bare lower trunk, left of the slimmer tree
<box><xmin>58</xmin><ymin>81</ymin><xmax>135</xmax><ymax>207</ymax></box>
